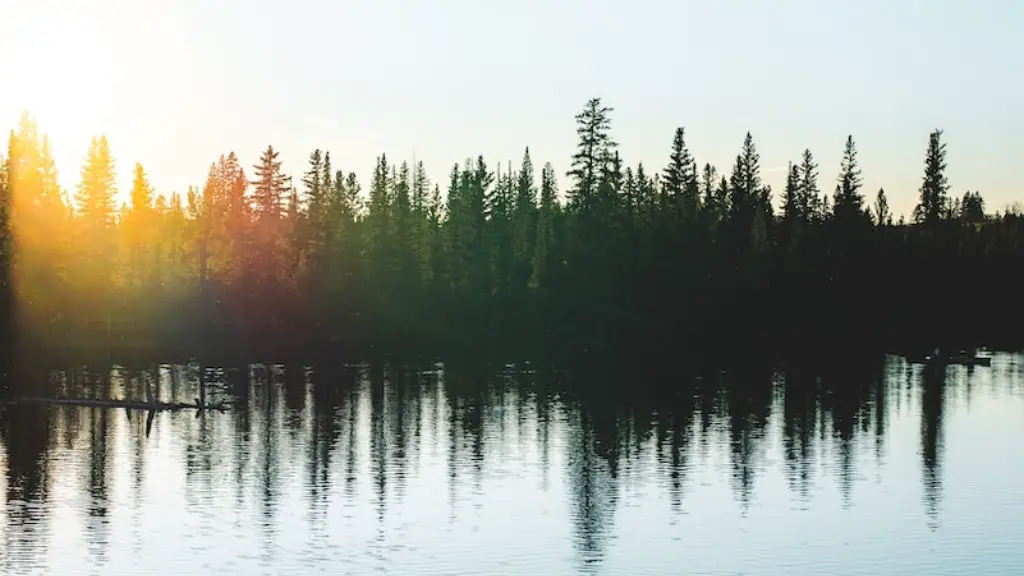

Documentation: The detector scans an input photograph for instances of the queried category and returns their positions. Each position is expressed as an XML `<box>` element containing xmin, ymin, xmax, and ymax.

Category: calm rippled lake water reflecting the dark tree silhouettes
<box><xmin>0</xmin><ymin>355</ymin><xmax>1024</xmax><ymax>576</ymax></box>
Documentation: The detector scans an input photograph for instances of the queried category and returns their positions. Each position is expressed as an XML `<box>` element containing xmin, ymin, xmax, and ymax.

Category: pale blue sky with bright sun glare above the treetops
<box><xmin>0</xmin><ymin>0</ymin><xmax>1024</xmax><ymax>213</ymax></box>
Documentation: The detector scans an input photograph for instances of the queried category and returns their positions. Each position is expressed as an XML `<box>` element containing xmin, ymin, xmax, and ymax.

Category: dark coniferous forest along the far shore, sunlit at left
<box><xmin>0</xmin><ymin>98</ymin><xmax>1024</xmax><ymax>363</ymax></box>
